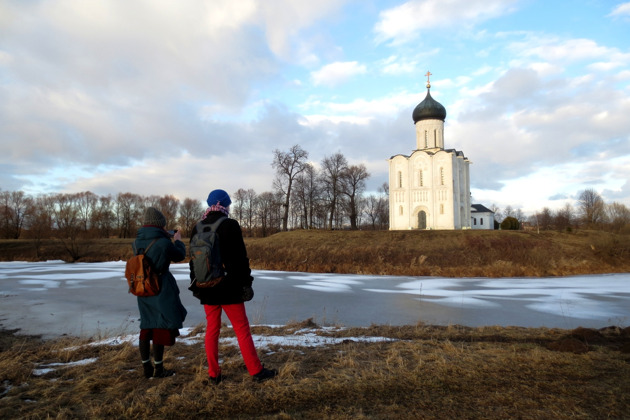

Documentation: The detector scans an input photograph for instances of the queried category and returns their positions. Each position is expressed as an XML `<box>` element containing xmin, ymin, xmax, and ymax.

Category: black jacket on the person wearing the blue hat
<box><xmin>189</xmin><ymin>211</ymin><xmax>254</xmax><ymax>305</ymax></box>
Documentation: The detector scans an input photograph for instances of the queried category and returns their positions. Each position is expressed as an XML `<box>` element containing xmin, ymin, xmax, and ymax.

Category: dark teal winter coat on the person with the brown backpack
<box><xmin>134</xmin><ymin>226</ymin><xmax>187</xmax><ymax>330</ymax></box>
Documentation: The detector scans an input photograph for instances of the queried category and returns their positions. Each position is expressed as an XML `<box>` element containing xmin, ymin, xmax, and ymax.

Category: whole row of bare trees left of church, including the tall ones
<box><xmin>0</xmin><ymin>146</ymin><xmax>389</xmax><ymax>244</ymax></box>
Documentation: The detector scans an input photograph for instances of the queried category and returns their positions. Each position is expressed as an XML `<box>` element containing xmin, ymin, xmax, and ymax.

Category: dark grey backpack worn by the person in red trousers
<box><xmin>190</xmin><ymin>216</ymin><xmax>227</xmax><ymax>288</ymax></box>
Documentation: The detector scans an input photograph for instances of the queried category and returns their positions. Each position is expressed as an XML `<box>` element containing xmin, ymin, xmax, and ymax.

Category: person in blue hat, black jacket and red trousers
<box><xmin>189</xmin><ymin>190</ymin><xmax>278</xmax><ymax>384</ymax></box>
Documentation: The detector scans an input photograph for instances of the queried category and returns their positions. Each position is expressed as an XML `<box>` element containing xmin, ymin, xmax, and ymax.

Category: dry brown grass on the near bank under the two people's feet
<box><xmin>0</xmin><ymin>322</ymin><xmax>630</xmax><ymax>419</ymax></box>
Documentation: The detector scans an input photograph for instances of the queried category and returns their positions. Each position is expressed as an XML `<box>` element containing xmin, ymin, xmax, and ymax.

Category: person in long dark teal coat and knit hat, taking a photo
<box><xmin>133</xmin><ymin>207</ymin><xmax>187</xmax><ymax>378</ymax></box>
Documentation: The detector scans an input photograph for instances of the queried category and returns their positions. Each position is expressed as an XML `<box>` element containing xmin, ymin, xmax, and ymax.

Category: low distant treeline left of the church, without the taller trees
<box><xmin>0</xmin><ymin>189</ymin><xmax>388</xmax><ymax>240</ymax></box>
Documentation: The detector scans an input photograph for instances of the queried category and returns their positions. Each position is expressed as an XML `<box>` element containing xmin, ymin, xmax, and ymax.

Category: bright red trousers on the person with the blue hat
<box><xmin>203</xmin><ymin>303</ymin><xmax>263</xmax><ymax>378</ymax></box>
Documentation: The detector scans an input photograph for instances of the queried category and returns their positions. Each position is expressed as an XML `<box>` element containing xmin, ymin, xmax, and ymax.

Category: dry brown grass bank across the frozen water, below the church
<box><xmin>0</xmin><ymin>230</ymin><xmax>630</xmax><ymax>277</ymax></box>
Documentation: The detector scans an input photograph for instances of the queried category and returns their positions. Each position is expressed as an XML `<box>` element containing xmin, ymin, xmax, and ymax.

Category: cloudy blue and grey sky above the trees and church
<box><xmin>0</xmin><ymin>0</ymin><xmax>630</xmax><ymax>213</ymax></box>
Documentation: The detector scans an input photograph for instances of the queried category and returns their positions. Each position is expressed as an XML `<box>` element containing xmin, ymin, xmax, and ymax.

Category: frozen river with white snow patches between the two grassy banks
<box><xmin>0</xmin><ymin>261</ymin><xmax>630</xmax><ymax>337</ymax></box>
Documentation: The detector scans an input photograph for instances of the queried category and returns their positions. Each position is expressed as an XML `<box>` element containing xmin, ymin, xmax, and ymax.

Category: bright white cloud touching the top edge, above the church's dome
<box><xmin>374</xmin><ymin>0</ymin><xmax>517</xmax><ymax>44</ymax></box>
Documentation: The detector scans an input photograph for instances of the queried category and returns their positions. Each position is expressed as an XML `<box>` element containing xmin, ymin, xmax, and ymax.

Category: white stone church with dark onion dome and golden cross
<box><xmin>389</xmin><ymin>77</ymin><xmax>471</xmax><ymax>230</ymax></box>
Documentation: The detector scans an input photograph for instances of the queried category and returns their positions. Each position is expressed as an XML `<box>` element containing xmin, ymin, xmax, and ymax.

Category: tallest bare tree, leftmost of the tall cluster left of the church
<box><xmin>271</xmin><ymin>144</ymin><xmax>308</xmax><ymax>231</ymax></box>
